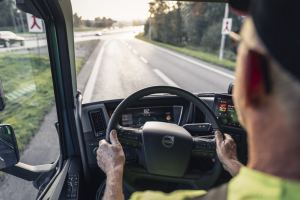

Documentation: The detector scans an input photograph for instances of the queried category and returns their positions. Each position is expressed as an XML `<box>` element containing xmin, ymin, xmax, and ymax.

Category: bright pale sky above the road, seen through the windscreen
<box><xmin>71</xmin><ymin>0</ymin><xmax>150</xmax><ymax>20</ymax></box>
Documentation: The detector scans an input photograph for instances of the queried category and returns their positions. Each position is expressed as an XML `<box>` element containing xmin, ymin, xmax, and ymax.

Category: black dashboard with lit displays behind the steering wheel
<box><xmin>82</xmin><ymin>94</ymin><xmax>247</xmax><ymax>168</ymax></box>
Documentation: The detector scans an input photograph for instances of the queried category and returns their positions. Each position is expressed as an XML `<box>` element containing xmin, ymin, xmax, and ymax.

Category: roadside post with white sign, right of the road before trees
<box><xmin>219</xmin><ymin>3</ymin><xmax>232</xmax><ymax>60</ymax></box>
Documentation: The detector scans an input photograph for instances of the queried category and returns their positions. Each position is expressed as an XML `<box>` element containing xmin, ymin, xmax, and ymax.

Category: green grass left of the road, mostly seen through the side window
<box><xmin>0</xmin><ymin>53</ymin><xmax>83</xmax><ymax>151</ymax></box>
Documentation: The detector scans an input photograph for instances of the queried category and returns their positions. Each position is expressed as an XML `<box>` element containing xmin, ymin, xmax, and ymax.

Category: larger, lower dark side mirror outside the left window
<box><xmin>0</xmin><ymin>124</ymin><xmax>20</xmax><ymax>170</ymax></box>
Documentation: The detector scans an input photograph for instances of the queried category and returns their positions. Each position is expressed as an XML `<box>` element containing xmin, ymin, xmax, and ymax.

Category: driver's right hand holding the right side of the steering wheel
<box><xmin>215</xmin><ymin>131</ymin><xmax>243</xmax><ymax>176</ymax></box>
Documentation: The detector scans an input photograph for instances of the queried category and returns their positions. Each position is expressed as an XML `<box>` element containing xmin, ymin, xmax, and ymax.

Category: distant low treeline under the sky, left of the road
<box><xmin>73</xmin><ymin>13</ymin><xmax>117</xmax><ymax>28</ymax></box>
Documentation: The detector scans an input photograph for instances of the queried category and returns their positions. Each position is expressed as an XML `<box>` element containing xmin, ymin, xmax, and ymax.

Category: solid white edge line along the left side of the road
<box><xmin>83</xmin><ymin>41</ymin><xmax>107</xmax><ymax>103</ymax></box>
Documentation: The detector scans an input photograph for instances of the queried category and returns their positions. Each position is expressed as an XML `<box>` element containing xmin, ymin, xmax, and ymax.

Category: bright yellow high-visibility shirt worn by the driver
<box><xmin>130</xmin><ymin>167</ymin><xmax>300</xmax><ymax>200</ymax></box>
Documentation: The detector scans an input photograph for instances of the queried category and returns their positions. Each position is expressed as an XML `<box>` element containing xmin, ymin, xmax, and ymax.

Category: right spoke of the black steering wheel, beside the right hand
<box><xmin>192</xmin><ymin>136</ymin><xmax>216</xmax><ymax>158</ymax></box>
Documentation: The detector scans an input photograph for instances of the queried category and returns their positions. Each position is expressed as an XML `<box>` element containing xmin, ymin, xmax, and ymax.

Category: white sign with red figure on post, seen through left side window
<box><xmin>26</xmin><ymin>13</ymin><xmax>44</xmax><ymax>57</ymax></box>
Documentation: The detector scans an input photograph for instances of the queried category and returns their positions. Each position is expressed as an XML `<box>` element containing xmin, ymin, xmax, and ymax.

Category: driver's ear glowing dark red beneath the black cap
<box><xmin>244</xmin><ymin>50</ymin><xmax>271</xmax><ymax>107</ymax></box>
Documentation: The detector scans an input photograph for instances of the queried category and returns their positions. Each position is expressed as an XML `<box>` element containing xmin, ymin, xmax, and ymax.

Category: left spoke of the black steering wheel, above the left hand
<box><xmin>117</xmin><ymin>125</ymin><xmax>143</xmax><ymax>148</ymax></box>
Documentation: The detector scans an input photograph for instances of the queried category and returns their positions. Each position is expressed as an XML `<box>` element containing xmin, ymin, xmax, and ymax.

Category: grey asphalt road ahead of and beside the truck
<box><xmin>0</xmin><ymin>29</ymin><xmax>234</xmax><ymax>200</ymax></box>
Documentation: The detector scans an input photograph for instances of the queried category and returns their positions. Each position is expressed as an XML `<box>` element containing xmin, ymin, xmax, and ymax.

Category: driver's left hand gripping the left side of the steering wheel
<box><xmin>97</xmin><ymin>130</ymin><xmax>125</xmax><ymax>175</ymax></box>
